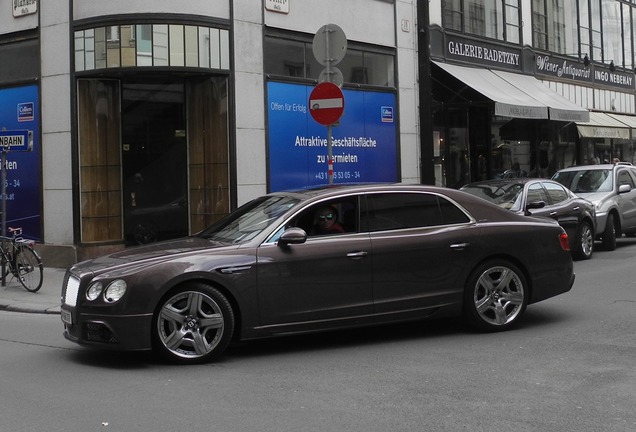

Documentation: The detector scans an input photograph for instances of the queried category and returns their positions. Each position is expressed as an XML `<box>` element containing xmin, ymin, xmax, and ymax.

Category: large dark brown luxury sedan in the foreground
<box><xmin>61</xmin><ymin>185</ymin><xmax>574</xmax><ymax>363</ymax></box>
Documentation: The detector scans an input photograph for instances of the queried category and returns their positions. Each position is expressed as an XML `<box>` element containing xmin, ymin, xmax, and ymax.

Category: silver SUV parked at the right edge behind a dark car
<box><xmin>552</xmin><ymin>162</ymin><xmax>636</xmax><ymax>250</ymax></box>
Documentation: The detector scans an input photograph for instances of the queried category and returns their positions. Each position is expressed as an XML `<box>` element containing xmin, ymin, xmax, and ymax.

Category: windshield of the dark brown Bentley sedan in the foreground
<box><xmin>198</xmin><ymin>196</ymin><xmax>300</xmax><ymax>243</ymax></box>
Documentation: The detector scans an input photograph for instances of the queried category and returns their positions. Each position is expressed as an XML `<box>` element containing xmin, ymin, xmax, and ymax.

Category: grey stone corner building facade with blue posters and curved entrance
<box><xmin>0</xmin><ymin>0</ymin><xmax>421</xmax><ymax>266</ymax></box>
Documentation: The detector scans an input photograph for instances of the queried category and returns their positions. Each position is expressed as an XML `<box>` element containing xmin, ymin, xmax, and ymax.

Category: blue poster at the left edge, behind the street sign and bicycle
<box><xmin>0</xmin><ymin>85</ymin><xmax>42</xmax><ymax>241</ymax></box>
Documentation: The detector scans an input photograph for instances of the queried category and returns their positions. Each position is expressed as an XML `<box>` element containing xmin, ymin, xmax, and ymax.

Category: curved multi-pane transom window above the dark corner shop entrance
<box><xmin>75</xmin><ymin>24</ymin><xmax>230</xmax><ymax>72</ymax></box>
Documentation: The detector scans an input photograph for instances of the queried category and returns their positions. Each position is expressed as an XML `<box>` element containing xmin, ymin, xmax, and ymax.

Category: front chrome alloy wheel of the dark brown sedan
<box><xmin>156</xmin><ymin>291</ymin><xmax>225</xmax><ymax>359</ymax></box>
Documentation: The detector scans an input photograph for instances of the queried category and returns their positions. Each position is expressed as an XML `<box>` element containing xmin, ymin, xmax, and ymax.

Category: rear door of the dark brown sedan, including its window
<box><xmin>365</xmin><ymin>192</ymin><xmax>480</xmax><ymax>315</ymax></box>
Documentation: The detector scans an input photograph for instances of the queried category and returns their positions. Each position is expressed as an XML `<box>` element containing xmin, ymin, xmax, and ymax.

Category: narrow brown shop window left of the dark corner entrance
<box><xmin>78</xmin><ymin>80</ymin><xmax>122</xmax><ymax>243</ymax></box>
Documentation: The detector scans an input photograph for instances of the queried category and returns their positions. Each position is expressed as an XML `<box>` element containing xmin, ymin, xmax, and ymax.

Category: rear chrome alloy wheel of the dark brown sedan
<box><xmin>473</xmin><ymin>266</ymin><xmax>525</xmax><ymax>326</ymax></box>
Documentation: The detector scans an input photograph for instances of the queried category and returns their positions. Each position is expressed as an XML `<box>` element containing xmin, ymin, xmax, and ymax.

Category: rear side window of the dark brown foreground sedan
<box><xmin>366</xmin><ymin>193</ymin><xmax>469</xmax><ymax>231</ymax></box>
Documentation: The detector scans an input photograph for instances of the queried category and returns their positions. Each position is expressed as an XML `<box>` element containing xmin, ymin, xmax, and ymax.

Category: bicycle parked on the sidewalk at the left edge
<box><xmin>0</xmin><ymin>228</ymin><xmax>44</xmax><ymax>292</ymax></box>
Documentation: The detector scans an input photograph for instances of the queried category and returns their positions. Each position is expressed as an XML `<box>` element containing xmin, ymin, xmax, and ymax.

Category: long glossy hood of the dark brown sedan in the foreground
<box><xmin>71</xmin><ymin>237</ymin><xmax>238</xmax><ymax>273</ymax></box>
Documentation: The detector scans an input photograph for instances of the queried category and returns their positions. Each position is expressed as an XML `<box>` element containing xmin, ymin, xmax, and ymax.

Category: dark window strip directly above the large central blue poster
<box><xmin>264</xmin><ymin>36</ymin><xmax>395</xmax><ymax>87</ymax></box>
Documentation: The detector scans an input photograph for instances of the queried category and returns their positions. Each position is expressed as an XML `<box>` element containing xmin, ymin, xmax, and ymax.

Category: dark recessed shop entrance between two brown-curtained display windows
<box><xmin>121</xmin><ymin>78</ymin><xmax>189</xmax><ymax>244</ymax></box>
